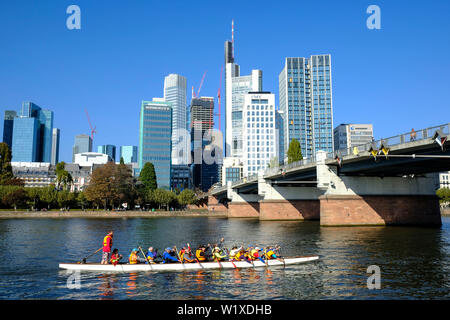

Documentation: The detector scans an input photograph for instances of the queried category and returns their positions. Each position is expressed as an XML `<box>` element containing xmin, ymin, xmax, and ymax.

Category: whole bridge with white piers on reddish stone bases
<box><xmin>208</xmin><ymin>124</ymin><xmax>450</xmax><ymax>226</ymax></box>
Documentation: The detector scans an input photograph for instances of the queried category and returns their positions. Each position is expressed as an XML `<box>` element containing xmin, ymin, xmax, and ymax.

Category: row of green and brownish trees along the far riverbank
<box><xmin>0</xmin><ymin>143</ymin><xmax>198</xmax><ymax>210</ymax></box>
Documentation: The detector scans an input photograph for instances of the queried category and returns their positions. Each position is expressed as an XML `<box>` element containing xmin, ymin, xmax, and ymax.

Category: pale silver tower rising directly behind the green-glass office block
<box><xmin>164</xmin><ymin>74</ymin><xmax>189</xmax><ymax>164</ymax></box>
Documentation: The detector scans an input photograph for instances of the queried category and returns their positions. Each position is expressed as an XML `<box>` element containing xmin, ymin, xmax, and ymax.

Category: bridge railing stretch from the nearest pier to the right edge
<box><xmin>327</xmin><ymin>123</ymin><xmax>450</xmax><ymax>159</ymax></box>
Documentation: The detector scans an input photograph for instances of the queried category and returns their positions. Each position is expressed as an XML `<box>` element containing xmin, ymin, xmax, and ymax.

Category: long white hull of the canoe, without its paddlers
<box><xmin>59</xmin><ymin>256</ymin><xmax>319</xmax><ymax>272</ymax></box>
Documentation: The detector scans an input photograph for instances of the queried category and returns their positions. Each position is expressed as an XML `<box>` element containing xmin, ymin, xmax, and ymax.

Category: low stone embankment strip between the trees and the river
<box><xmin>0</xmin><ymin>209</ymin><xmax>227</xmax><ymax>219</ymax></box>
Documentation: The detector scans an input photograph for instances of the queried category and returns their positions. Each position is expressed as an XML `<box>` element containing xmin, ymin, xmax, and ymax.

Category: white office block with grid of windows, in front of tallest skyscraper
<box><xmin>242</xmin><ymin>92</ymin><xmax>278</xmax><ymax>177</ymax></box>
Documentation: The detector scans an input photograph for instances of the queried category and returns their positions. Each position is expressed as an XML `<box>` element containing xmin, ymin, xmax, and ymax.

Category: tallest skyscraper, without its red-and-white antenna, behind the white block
<box><xmin>225</xmin><ymin>41</ymin><xmax>262</xmax><ymax>157</ymax></box>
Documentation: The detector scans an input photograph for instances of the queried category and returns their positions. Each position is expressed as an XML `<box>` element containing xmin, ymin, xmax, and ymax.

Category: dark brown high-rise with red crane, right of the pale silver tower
<box><xmin>191</xmin><ymin>97</ymin><xmax>220</xmax><ymax>191</ymax></box>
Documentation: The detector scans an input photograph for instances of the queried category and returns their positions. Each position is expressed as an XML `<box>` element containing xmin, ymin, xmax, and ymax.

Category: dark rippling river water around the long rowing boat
<box><xmin>0</xmin><ymin>217</ymin><xmax>450</xmax><ymax>300</ymax></box>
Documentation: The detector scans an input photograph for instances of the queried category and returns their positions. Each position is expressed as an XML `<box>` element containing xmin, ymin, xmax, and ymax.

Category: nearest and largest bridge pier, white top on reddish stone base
<box><xmin>317</xmin><ymin>151</ymin><xmax>442</xmax><ymax>226</ymax></box>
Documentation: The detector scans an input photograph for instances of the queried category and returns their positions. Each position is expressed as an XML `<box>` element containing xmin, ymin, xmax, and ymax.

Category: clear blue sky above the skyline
<box><xmin>0</xmin><ymin>0</ymin><xmax>450</xmax><ymax>162</ymax></box>
